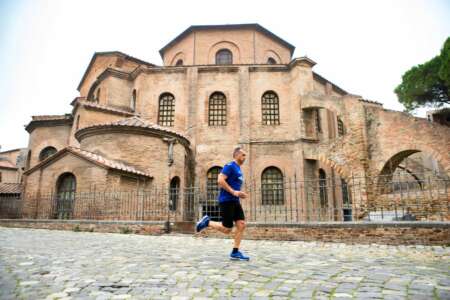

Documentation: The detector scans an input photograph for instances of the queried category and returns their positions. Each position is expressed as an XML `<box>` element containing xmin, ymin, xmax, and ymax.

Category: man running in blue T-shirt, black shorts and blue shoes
<box><xmin>196</xmin><ymin>147</ymin><xmax>250</xmax><ymax>260</ymax></box>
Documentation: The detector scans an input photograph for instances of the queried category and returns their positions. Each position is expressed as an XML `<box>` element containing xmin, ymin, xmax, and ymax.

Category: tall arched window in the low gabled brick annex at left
<box><xmin>56</xmin><ymin>173</ymin><xmax>77</xmax><ymax>219</ymax></box>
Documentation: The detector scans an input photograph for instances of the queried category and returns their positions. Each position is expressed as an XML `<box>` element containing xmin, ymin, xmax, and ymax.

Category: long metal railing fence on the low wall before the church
<box><xmin>0</xmin><ymin>175</ymin><xmax>450</xmax><ymax>223</ymax></box>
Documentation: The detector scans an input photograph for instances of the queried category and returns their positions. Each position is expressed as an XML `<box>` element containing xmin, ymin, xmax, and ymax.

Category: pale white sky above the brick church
<box><xmin>0</xmin><ymin>0</ymin><xmax>450</xmax><ymax>151</ymax></box>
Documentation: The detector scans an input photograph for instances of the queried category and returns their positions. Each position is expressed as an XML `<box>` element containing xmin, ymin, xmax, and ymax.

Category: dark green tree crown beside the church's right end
<box><xmin>394</xmin><ymin>37</ymin><xmax>450</xmax><ymax>112</ymax></box>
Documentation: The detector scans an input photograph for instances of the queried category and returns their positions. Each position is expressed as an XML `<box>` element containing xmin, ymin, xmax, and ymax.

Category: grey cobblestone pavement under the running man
<box><xmin>0</xmin><ymin>227</ymin><xmax>450</xmax><ymax>299</ymax></box>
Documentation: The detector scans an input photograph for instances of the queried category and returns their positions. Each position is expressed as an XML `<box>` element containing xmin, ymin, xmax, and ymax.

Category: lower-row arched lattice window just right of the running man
<box><xmin>261</xmin><ymin>167</ymin><xmax>284</xmax><ymax>205</ymax></box>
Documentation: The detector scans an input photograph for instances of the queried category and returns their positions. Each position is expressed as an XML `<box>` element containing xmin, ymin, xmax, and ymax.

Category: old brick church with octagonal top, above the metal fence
<box><xmin>15</xmin><ymin>24</ymin><xmax>450</xmax><ymax>220</ymax></box>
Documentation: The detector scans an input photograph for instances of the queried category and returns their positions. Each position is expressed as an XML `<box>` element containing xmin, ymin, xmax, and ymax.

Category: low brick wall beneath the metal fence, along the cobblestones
<box><xmin>0</xmin><ymin>219</ymin><xmax>450</xmax><ymax>245</ymax></box>
